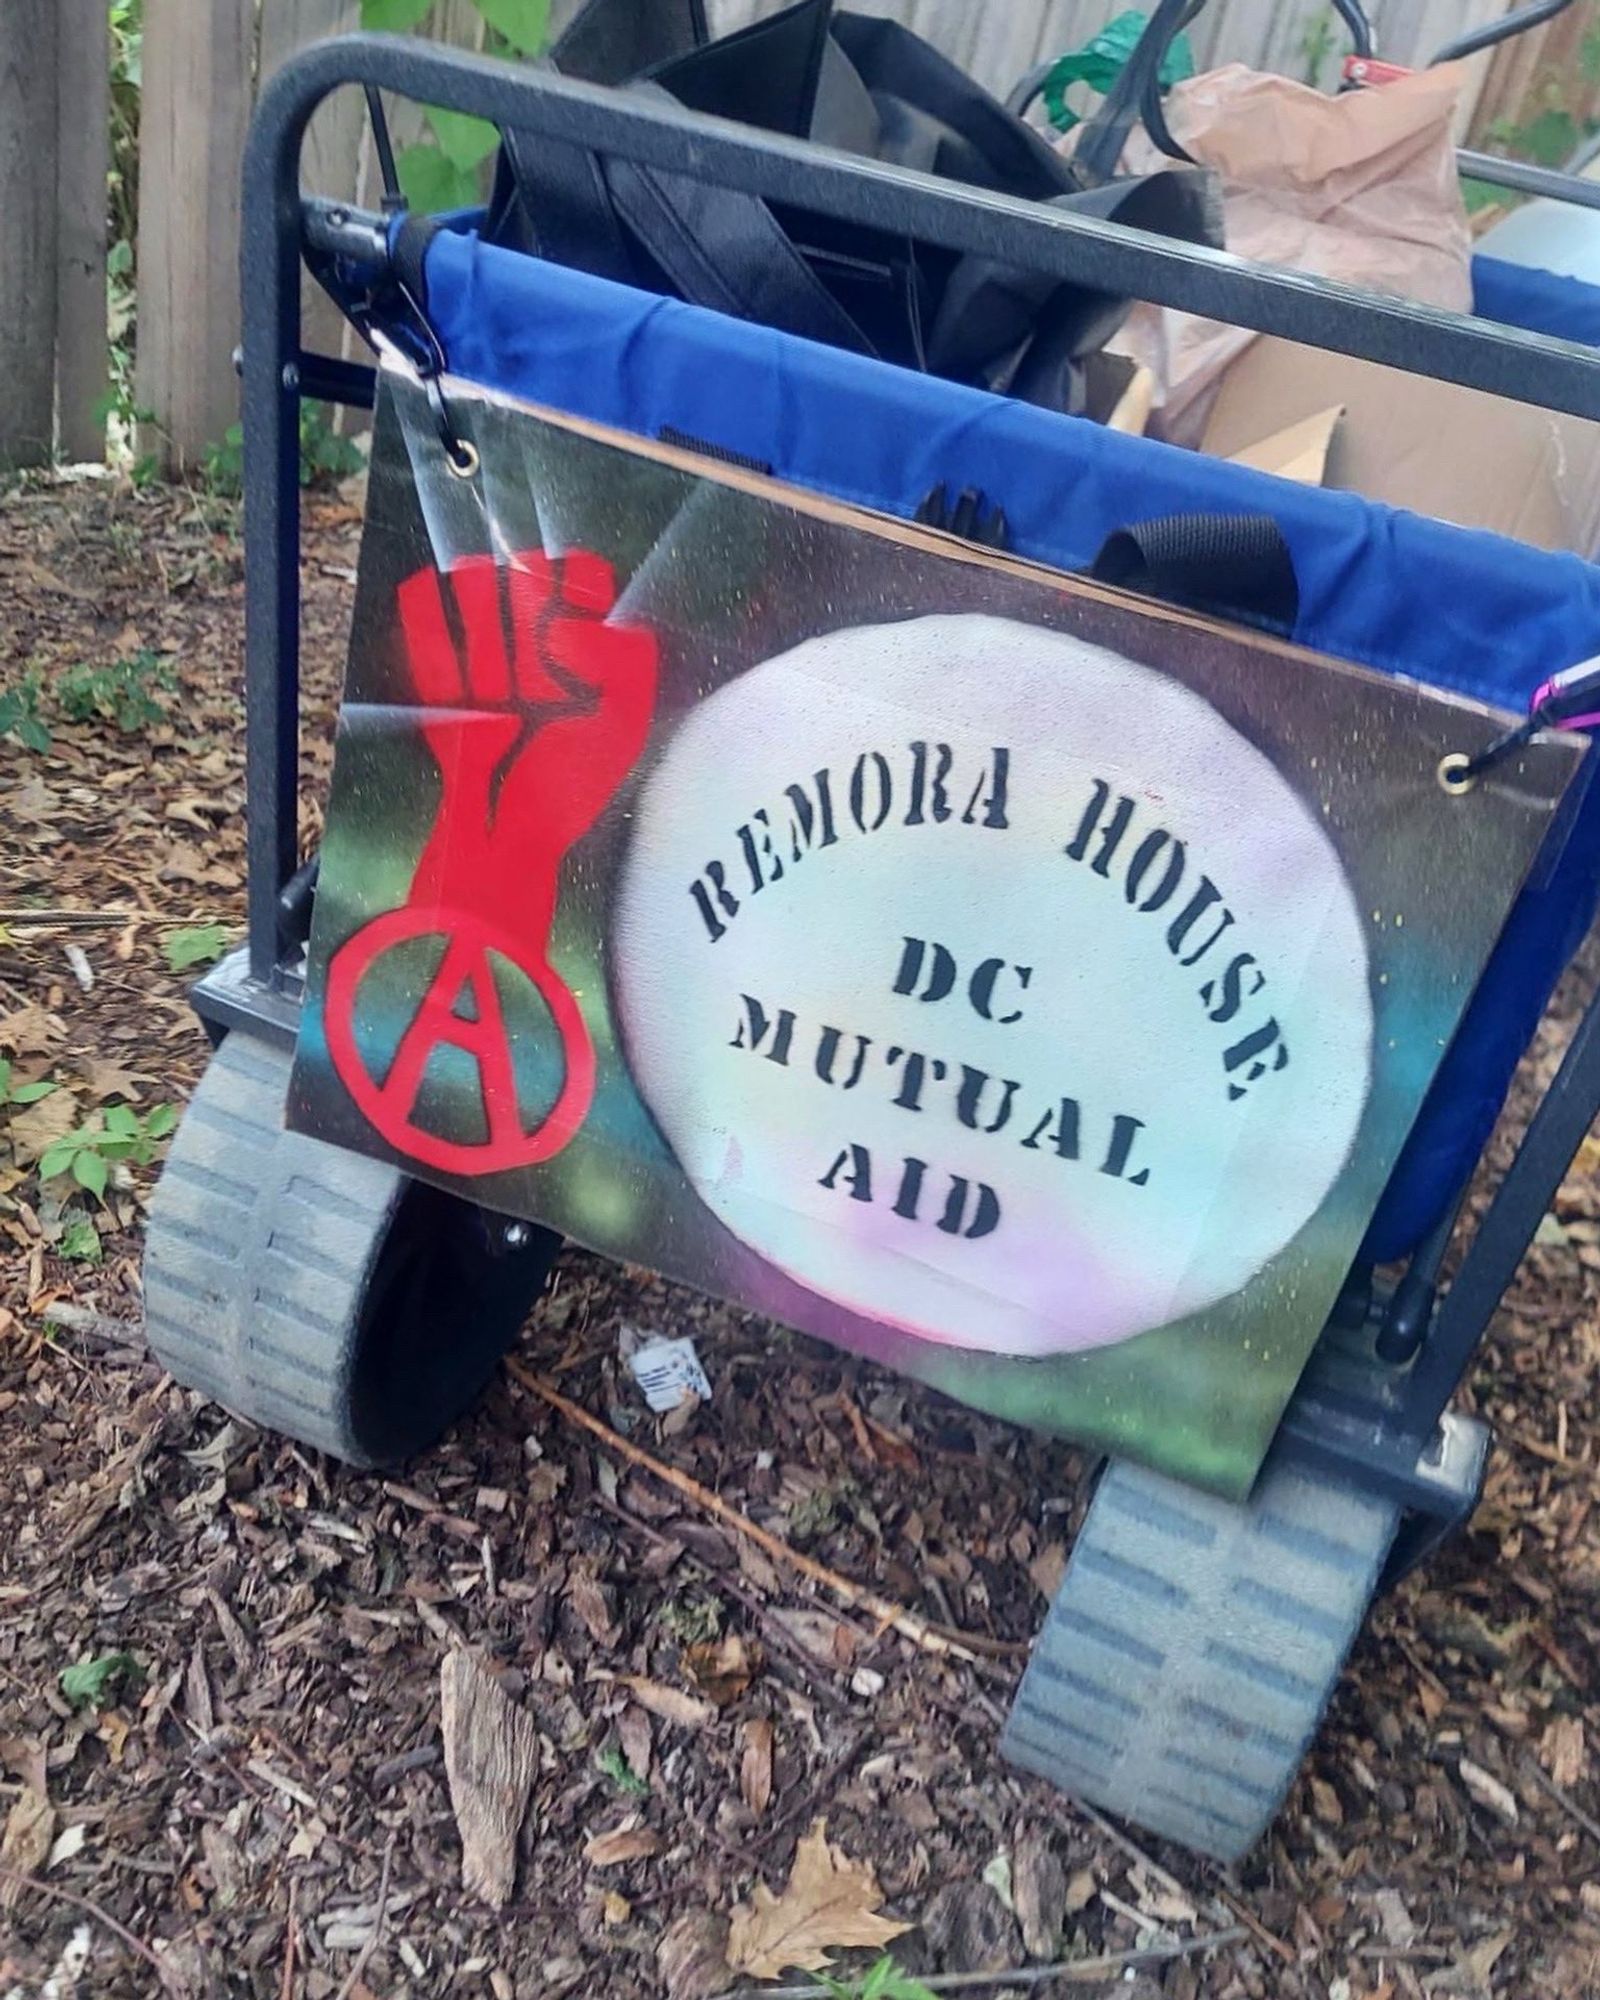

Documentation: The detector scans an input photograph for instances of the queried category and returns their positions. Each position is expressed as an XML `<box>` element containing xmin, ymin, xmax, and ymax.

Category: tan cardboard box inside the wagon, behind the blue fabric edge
<box><xmin>1202</xmin><ymin>336</ymin><xmax>1600</xmax><ymax>556</ymax></box>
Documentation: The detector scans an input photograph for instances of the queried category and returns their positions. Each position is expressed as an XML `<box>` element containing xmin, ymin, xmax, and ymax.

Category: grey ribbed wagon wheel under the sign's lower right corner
<box><xmin>1000</xmin><ymin>1460</ymin><xmax>1398</xmax><ymax>1862</ymax></box>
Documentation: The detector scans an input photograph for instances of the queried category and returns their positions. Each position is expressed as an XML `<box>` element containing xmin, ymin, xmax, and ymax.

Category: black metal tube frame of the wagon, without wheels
<box><xmin>219</xmin><ymin>34</ymin><xmax>1600</xmax><ymax>1572</ymax></box>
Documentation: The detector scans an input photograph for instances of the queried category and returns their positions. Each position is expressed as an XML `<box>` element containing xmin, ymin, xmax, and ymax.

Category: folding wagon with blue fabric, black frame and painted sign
<box><xmin>144</xmin><ymin>19</ymin><xmax>1600</xmax><ymax>1858</ymax></box>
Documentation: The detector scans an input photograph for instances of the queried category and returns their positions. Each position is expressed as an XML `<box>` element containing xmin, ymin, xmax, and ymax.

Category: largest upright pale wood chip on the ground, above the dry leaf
<box><xmin>438</xmin><ymin>1648</ymin><xmax>538</xmax><ymax>1910</ymax></box>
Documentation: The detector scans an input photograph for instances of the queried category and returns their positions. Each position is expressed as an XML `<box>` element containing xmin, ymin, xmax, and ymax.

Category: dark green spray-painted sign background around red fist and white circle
<box><xmin>290</xmin><ymin>382</ymin><xmax>1576</xmax><ymax>1494</ymax></box>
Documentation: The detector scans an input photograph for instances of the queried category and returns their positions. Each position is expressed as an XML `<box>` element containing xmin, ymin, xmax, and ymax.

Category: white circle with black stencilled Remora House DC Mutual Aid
<box><xmin>612</xmin><ymin>616</ymin><xmax>1372</xmax><ymax>1354</ymax></box>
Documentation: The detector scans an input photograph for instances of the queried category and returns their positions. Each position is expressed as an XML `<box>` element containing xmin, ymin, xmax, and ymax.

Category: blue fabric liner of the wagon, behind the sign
<box><xmin>426</xmin><ymin>230</ymin><xmax>1600</xmax><ymax>1260</ymax></box>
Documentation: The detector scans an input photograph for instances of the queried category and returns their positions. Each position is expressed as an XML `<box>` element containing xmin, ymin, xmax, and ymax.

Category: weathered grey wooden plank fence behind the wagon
<box><xmin>0</xmin><ymin>0</ymin><xmax>1596</xmax><ymax>468</ymax></box>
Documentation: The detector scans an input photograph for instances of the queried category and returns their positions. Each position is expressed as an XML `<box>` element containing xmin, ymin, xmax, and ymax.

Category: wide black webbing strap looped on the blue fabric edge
<box><xmin>1088</xmin><ymin>514</ymin><xmax>1300</xmax><ymax>636</ymax></box>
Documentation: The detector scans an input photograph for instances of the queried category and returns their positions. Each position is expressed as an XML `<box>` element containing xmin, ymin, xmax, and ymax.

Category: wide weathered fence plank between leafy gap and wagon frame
<box><xmin>138</xmin><ymin>0</ymin><xmax>256</xmax><ymax>470</ymax></box>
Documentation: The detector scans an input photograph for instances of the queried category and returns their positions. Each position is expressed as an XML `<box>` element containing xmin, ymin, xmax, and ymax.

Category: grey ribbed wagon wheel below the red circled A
<box><xmin>144</xmin><ymin>1030</ymin><xmax>560</xmax><ymax>1466</ymax></box>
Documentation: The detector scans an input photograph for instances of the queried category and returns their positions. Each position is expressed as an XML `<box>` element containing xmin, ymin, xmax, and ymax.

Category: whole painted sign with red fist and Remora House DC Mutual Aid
<box><xmin>292</xmin><ymin>364</ymin><xmax>1576</xmax><ymax>1492</ymax></box>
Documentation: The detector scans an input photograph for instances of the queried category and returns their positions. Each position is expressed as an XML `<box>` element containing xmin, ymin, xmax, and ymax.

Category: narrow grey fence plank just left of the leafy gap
<box><xmin>56</xmin><ymin>0</ymin><xmax>112</xmax><ymax>464</ymax></box>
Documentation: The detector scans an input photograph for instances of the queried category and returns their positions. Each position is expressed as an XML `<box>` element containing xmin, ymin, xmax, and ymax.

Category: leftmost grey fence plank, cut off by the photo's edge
<box><xmin>0</xmin><ymin>0</ymin><xmax>56</xmax><ymax>468</ymax></box>
